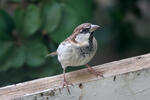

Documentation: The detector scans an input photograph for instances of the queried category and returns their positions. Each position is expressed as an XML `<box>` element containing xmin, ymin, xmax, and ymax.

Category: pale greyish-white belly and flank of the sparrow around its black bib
<box><xmin>57</xmin><ymin>38</ymin><xmax>97</xmax><ymax>67</ymax></box>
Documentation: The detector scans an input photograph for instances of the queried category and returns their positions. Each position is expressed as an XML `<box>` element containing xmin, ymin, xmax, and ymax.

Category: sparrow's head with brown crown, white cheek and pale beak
<box><xmin>72</xmin><ymin>23</ymin><xmax>99</xmax><ymax>42</ymax></box>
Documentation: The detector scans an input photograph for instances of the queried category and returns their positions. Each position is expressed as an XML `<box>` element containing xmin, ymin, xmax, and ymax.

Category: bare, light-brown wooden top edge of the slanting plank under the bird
<box><xmin>0</xmin><ymin>54</ymin><xmax>150</xmax><ymax>100</ymax></box>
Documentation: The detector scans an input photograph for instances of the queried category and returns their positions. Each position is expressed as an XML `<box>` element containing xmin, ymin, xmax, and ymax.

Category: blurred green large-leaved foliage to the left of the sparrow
<box><xmin>0</xmin><ymin>0</ymin><xmax>93</xmax><ymax>86</ymax></box>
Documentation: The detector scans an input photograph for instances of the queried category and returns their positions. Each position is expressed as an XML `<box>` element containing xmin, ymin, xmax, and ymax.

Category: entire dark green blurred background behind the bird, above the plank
<box><xmin>0</xmin><ymin>0</ymin><xmax>150</xmax><ymax>87</ymax></box>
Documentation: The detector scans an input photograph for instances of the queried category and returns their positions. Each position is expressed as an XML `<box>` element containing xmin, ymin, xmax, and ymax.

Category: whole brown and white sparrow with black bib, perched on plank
<box><xmin>47</xmin><ymin>23</ymin><xmax>103</xmax><ymax>87</ymax></box>
